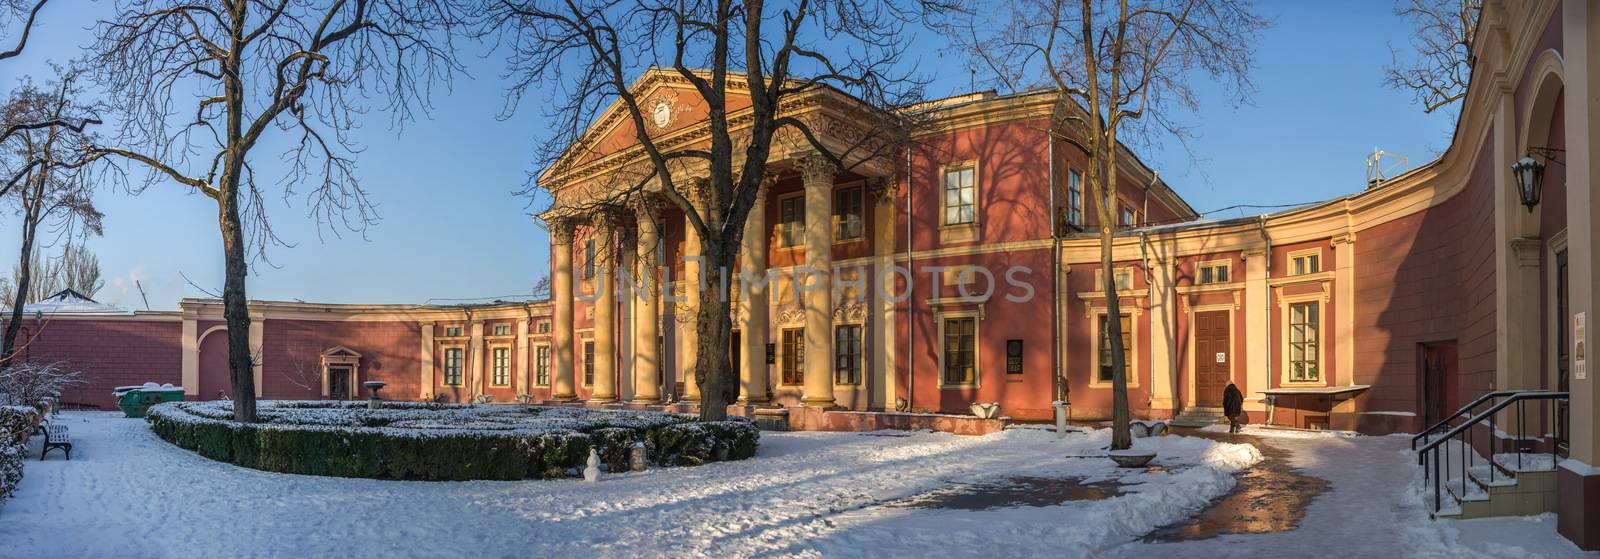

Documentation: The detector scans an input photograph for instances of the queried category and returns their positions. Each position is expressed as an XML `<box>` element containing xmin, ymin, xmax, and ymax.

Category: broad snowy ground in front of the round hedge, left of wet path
<box><xmin>0</xmin><ymin>412</ymin><xmax>1261</xmax><ymax>557</ymax></box>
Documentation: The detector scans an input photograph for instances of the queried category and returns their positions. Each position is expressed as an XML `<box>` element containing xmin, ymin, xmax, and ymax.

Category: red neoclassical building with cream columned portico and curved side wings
<box><xmin>15</xmin><ymin>0</ymin><xmax>1600</xmax><ymax>548</ymax></box>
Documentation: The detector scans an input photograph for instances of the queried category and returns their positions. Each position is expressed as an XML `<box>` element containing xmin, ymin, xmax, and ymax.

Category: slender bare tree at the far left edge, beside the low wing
<box><xmin>0</xmin><ymin>70</ymin><xmax>101</xmax><ymax>363</ymax></box>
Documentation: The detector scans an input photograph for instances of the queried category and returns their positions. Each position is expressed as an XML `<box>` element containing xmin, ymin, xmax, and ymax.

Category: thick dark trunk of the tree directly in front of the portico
<box><xmin>690</xmin><ymin>232</ymin><xmax>739</xmax><ymax>421</ymax></box>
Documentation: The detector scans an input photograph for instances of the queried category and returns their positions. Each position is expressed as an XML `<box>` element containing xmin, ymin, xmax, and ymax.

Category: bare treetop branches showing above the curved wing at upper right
<box><xmin>1384</xmin><ymin>0</ymin><xmax>1483</xmax><ymax>112</ymax></box>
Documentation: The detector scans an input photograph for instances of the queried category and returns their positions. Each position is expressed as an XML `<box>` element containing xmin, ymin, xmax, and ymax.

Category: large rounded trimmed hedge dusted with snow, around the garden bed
<box><xmin>146</xmin><ymin>402</ymin><xmax>760</xmax><ymax>481</ymax></box>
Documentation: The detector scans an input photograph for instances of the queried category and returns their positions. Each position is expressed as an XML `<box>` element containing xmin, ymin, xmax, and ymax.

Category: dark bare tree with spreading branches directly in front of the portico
<box><xmin>475</xmin><ymin>0</ymin><xmax>939</xmax><ymax>420</ymax></box>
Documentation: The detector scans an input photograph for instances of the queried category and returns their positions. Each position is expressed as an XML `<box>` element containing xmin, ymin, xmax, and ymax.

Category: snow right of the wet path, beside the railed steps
<box><xmin>1110</xmin><ymin>426</ymin><xmax>1584</xmax><ymax>557</ymax></box>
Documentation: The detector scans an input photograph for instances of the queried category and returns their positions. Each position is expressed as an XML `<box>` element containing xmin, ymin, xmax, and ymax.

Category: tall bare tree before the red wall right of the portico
<box><xmin>950</xmin><ymin>0</ymin><xmax>1269</xmax><ymax>450</ymax></box>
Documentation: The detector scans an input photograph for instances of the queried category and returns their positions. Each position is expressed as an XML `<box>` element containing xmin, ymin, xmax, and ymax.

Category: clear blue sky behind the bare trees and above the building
<box><xmin>0</xmin><ymin>2</ymin><xmax>1454</xmax><ymax>309</ymax></box>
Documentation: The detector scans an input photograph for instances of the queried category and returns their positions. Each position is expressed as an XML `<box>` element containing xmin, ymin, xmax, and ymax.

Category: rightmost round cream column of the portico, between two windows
<box><xmin>800</xmin><ymin>157</ymin><xmax>837</xmax><ymax>407</ymax></box>
